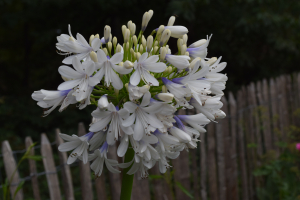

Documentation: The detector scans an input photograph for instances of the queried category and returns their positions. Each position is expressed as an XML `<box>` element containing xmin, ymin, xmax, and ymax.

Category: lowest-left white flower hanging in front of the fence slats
<box><xmin>58</xmin><ymin>132</ymin><xmax>94</xmax><ymax>164</ymax></box>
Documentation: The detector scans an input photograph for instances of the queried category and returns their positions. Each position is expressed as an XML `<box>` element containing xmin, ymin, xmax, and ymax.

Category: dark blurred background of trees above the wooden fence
<box><xmin>0</xmin><ymin>0</ymin><xmax>300</xmax><ymax>199</ymax></box>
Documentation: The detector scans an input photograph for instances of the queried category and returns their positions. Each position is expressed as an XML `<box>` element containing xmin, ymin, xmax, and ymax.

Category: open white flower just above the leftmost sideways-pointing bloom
<box><xmin>58</xmin><ymin>57</ymin><xmax>100</xmax><ymax>101</ymax></box>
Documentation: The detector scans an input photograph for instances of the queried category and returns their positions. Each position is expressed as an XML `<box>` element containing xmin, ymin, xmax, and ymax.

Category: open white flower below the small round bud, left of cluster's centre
<box><xmin>89</xmin><ymin>103</ymin><xmax>133</xmax><ymax>145</ymax></box>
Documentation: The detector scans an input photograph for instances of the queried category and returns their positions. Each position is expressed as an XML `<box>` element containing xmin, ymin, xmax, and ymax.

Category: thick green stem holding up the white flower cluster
<box><xmin>120</xmin><ymin>145</ymin><xmax>134</xmax><ymax>200</ymax></box>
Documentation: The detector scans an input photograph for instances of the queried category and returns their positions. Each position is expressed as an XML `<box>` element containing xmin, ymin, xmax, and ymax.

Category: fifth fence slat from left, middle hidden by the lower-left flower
<box><xmin>78</xmin><ymin>122</ymin><xmax>93</xmax><ymax>200</ymax></box>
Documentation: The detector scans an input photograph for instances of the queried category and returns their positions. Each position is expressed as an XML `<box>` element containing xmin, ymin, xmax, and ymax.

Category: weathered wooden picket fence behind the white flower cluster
<box><xmin>2</xmin><ymin>74</ymin><xmax>300</xmax><ymax>200</ymax></box>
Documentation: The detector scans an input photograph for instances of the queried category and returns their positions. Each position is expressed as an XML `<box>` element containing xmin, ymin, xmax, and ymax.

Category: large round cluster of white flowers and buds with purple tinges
<box><xmin>32</xmin><ymin>10</ymin><xmax>227</xmax><ymax>177</ymax></box>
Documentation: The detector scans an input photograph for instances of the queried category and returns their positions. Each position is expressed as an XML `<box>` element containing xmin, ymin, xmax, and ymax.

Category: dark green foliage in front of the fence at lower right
<box><xmin>253</xmin><ymin>145</ymin><xmax>300</xmax><ymax>200</ymax></box>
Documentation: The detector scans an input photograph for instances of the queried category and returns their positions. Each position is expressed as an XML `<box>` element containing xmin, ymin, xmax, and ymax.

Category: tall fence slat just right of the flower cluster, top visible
<box><xmin>226</xmin><ymin>92</ymin><xmax>239</xmax><ymax>200</ymax></box>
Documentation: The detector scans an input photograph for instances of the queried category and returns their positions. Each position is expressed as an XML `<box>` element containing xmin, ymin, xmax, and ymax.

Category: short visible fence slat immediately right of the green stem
<box><xmin>131</xmin><ymin>173</ymin><xmax>151</xmax><ymax>200</ymax></box>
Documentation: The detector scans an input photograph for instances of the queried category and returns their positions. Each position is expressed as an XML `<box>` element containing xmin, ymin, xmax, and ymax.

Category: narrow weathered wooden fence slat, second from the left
<box><xmin>25</xmin><ymin>136</ymin><xmax>41</xmax><ymax>200</ymax></box>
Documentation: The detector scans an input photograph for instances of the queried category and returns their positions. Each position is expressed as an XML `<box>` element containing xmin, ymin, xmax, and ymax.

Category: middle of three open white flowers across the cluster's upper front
<box><xmin>95</xmin><ymin>49</ymin><xmax>132</xmax><ymax>90</ymax></box>
